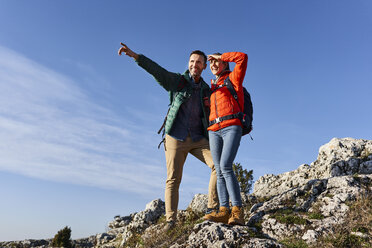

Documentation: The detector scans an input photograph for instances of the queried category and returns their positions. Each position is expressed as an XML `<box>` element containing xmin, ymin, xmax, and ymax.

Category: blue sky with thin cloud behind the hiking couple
<box><xmin>0</xmin><ymin>0</ymin><xmax>372</xmax><ymax>241</ymax></box>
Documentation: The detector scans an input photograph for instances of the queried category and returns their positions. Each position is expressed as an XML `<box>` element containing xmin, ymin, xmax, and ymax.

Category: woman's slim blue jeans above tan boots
<box><xmin>209</xmin><ymin>126</ymin><xmax>242</xmax><ymax>208</ymax></box>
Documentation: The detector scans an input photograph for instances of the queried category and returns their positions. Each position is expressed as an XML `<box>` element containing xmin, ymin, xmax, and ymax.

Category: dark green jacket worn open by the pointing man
<box><xmin>136</xmin><ymin>54</ymin><xmax>210</xmax><ymax>139</ymax></box>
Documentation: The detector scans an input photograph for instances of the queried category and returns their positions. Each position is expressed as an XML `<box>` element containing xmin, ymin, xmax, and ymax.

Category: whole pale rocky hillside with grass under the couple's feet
<box><xmin>0</xmin><ymin>138</ymin><xmax>372</xmax><ymax>248</ymax></box>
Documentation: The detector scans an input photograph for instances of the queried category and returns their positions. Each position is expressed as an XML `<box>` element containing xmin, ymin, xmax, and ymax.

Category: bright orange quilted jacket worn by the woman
<box><xmin>208</xmin><ymin>52</ymin><xmax>248</xmax><ymax>131</ymax></box>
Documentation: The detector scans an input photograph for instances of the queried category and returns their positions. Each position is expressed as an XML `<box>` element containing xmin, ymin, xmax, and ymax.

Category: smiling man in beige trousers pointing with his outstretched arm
<box><xmin>118</xmin><ymin>43</ymin><xmax>218</xmax><ymax>230</ymax></box>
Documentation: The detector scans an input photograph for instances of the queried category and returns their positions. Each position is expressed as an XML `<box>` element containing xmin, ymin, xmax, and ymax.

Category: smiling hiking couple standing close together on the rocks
<box><xmin>118</xmin><ymin>43</ymin><xmax>248</xmax><ymax>230</ymax></box>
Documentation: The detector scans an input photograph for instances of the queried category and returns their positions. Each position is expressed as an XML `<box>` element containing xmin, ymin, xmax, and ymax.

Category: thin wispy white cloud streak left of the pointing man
<box><xmin>0</xmin><ymin>46</ymin><xmax>165</xmax><ymax>194</ymax></box>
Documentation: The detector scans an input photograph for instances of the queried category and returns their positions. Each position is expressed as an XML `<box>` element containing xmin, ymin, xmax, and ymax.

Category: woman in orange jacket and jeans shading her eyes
<box><xmin>204</xmin><ymin>52</ymin><xmax>248</xmax><ymax>225</ymax></box>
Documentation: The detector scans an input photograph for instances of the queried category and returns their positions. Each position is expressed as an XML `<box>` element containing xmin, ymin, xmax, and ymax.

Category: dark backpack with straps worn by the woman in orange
<box><xmin>211</xmin><ymin>77</ymin><xmax>253</xmax><ymax>137</ymax></box>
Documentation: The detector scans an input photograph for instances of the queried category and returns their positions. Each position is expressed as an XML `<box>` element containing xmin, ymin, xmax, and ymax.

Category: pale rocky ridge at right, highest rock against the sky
<box><xmin>253</xmin><ymin>138</ymin><xmax>372</xmax><ymax>197</ymax></box>
